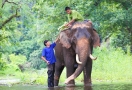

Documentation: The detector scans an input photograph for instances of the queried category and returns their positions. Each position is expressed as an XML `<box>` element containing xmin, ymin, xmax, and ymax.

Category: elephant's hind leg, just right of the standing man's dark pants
<box><xmin>54</xmin><ymin>65</ymin><xmax>64</xmax><ymax>86</ymax></box>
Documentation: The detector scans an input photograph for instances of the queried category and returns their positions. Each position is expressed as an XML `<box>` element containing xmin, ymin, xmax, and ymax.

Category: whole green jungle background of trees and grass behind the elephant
<box><xmin>0</xmin><ymin>0</ymin><xmax>132</xmax><ymax>85</ymax></box>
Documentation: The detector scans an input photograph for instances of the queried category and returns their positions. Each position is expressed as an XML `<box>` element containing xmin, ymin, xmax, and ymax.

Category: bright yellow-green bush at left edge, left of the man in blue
<box><xmin>0</xmin><ymin>54</ymin><xmax>27</xmax><ymax>76</ymax></box>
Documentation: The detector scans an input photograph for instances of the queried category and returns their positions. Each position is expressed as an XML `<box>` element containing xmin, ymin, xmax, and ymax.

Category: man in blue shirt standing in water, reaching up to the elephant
<box><xmin>41</xmin><ymin>40</ymin><xmax>57</xmax><ymax>87</ymax></box>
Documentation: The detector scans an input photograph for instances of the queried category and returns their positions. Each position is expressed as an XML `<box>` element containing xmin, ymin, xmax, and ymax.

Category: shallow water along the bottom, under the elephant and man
<box><xmin>0</xmin><ymin>84</ymin><xmax>132</xmax><ymax>90</ymax></box>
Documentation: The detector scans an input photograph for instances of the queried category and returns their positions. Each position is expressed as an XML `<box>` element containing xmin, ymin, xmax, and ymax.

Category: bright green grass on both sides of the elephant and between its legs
<box><xmin>0</xmin><ymin>47</ymin><xmax>132</xmax><ymax>85</ymax></box>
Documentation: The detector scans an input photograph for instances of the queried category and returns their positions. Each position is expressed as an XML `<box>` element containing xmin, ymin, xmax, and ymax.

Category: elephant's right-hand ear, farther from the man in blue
<box><xmin>93</xmin><ymin>29</ymin><xmax>100</xmax><ymax>47</ymax></box>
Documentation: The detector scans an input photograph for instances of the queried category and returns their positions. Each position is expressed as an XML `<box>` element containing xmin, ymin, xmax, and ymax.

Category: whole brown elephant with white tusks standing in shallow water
<box><xmin>54</xmin><ymin>21</ymin><xmax>100</xmax><ymax>86</ymax></box>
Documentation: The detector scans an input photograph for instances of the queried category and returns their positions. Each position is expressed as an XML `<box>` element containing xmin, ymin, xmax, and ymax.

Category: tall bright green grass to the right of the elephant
<box><xmin>92</xmin><ymin>47</ymin><xmax>132</xmax><ymax>82</ymax></box>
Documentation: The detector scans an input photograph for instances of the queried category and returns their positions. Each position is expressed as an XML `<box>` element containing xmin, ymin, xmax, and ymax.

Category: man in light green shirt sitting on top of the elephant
<box><xmin>65</xmin><ymin>7</ymin><xmax>92</xmax><ymax>27</ymax></box>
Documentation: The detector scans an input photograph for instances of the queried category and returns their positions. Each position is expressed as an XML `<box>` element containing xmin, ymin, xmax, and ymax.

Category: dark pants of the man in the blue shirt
<box><xmin>47</xmin><ymin>63</ymin><xmax>55</xmax><ymax>87</ymax></box>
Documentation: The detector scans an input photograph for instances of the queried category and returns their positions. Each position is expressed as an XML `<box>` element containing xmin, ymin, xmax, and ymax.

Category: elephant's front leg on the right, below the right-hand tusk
<box><xmin>83</xmin><ymin>59</ymin><xmax>92</xmax><ymax>86</ymax></box>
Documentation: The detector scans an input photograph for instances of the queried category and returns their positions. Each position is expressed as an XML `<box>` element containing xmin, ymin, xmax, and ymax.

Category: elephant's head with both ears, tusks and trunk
<box><xmin>60</xmin><ymin>21</ymin><xmax>100</xmax><ymax>83</ymax></box>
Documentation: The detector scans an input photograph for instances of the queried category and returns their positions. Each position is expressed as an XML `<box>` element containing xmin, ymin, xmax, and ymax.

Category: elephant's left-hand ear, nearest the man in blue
<box><xmin>59</xmin><ymin>29</ymin><xmax>71</xmax><ymax>49</ymax></box>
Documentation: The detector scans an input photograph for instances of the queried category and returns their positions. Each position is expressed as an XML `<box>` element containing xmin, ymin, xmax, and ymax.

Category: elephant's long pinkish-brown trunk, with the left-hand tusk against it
<box><xmin>65</xmin><ymin>40</ymin><xmax>91</xmax><ymax>84</ymax></box>
